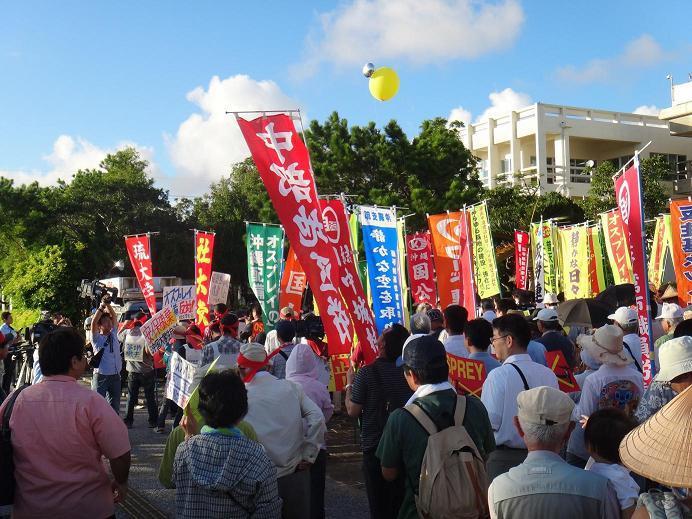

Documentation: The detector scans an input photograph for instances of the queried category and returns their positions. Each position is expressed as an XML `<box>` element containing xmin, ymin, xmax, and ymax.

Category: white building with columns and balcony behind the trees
<box><xmin>460</xmin><ymin>103</ymin><xmax>692</xmax><ymax>198</ymax></box>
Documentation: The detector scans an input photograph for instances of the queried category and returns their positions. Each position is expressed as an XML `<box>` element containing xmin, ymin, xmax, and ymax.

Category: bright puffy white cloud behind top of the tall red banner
<box><xmin>165</xmin><ymin>75</ymin><xmax>298</xmax><ymax>196</ymax></box>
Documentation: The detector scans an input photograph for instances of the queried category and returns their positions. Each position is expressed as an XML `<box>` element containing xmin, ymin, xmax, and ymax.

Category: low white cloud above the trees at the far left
<box><xmin>0</xmin><ymin>135</ymin><xmax>161</xmax><ymax>186</ymax></box>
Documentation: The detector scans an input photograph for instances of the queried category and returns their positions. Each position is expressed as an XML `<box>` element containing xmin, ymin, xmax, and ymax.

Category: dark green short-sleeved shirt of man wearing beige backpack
<box><xmin>376</xmin><ymin>389</ymin><xmax>495</xmax><ymax>519</ymax></box>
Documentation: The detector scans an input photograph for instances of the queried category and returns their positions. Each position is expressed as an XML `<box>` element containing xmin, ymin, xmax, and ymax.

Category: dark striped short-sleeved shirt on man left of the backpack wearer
<box><xmin>351</xmin><ymin>358</ymin><xmax>413</xmax><ymax>451</ymax></box>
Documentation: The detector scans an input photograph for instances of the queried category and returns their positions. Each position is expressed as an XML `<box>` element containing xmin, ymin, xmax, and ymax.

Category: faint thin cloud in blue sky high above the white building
<box><xmin>556</xmin><ymin>34</ymin><xmax>669</xmax><ymax>84</ymax></box>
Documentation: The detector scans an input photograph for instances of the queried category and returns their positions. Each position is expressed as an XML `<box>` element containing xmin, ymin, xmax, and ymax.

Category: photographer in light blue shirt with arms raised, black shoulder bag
<box><xmin>91</xmin><ymin>295</ymin><xmax>122</xmax><ymax>415</ymax></box>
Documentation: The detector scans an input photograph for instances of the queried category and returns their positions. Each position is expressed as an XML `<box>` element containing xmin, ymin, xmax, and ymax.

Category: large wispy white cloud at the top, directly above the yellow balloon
<box><xmin>293</xmin><ymin>0</ymin><xmax>524</xmax><ymax>76</ymax></box>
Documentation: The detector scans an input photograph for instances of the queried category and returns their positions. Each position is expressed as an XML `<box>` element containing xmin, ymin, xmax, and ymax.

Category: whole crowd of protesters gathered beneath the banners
<box><xmin>0</xmin><ymin>288</ymin><xmax>692</xmax><ymax>519</ymax></box>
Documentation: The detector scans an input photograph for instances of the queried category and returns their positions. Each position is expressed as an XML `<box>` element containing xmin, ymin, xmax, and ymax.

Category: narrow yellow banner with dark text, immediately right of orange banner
<box><xmin>467</xmin><ymin>202</ymin><xmax>500</xmax><ymax>299</ymax></box>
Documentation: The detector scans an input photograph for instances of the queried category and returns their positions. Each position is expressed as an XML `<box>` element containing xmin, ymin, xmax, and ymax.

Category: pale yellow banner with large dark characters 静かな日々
<box><xmin>558</xmin><ymin>225</ymin><xmax>591</xmax><ymax>299</ymax></box>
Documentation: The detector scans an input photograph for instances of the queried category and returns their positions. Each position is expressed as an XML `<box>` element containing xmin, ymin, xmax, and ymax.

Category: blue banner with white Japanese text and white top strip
<box><xmin>359</xmin><ymin>206</ymin><xmax>404</xmax><ymax>334</ymax></box>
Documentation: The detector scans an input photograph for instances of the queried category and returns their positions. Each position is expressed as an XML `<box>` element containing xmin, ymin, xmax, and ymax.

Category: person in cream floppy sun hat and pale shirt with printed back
<box><xmin>567</xmin><ymin>324</ymin><xmax>644</xmax><ymax>468</ymax></box>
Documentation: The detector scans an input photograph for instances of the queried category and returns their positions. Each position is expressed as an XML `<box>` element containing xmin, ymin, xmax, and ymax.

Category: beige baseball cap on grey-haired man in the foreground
<box><xmin>517</xmin><ymin>386</ymin><xmax>574</xmax><ymax>425</ymax></box>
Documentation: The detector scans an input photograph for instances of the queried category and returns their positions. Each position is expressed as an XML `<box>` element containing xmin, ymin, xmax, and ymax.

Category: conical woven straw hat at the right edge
<box><xmin>620</xmin><ymin>387</ymin><xmax>692</xmax><ymax>488</ymax></box>
